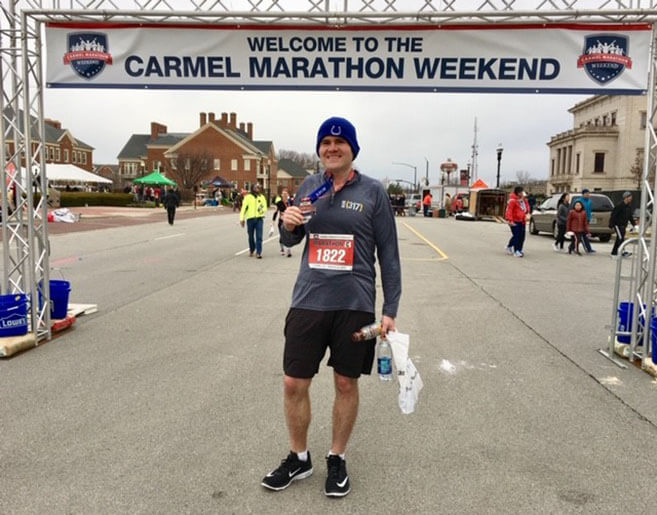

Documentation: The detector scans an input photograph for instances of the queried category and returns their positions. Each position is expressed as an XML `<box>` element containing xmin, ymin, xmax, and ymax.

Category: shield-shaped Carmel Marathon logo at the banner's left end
<box><xmin>64</xmin><ymin>32</ymin><xmax>112</xmax><ymax>79</ymax></box>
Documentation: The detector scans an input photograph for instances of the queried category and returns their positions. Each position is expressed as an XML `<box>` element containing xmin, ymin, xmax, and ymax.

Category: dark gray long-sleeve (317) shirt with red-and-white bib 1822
<box><xmin>281</xmin><ymin>172</ymin><xmax>401</xmax><ymax>318</ymax></box>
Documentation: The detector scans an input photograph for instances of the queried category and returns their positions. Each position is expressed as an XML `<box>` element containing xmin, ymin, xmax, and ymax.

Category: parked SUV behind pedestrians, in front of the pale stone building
<box><xmin>529</xmin><ymin>193</ymin><xmax>614</xmax><ymax>242</ymax></box>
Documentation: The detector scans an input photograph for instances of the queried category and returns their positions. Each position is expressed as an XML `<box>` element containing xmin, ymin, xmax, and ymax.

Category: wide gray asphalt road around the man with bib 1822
<box><xmin>0</xmin><ymin>214</ymin><xmax>657</xmax><ymax>513</ymax></box>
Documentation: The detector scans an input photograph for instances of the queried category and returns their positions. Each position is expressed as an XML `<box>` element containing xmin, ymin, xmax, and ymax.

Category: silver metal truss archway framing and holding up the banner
<box><xmin>0</xmin><ymin>0</ymin><xmax>657</xmax><ymax>348</ymax></box>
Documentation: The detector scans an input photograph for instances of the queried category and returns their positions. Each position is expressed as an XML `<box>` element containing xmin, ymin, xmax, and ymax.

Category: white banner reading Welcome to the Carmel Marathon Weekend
<box><xmin>46</xmin><ymin>23</ymin><xmax>651</xmax><ymax>95</ymax></box>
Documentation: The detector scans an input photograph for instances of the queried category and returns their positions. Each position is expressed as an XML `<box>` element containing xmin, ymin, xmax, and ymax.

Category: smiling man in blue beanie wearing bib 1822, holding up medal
<box><xmin>262</xmin><ymin>117</ymin><xmax>401</xmax><ymax>497</ymax></box>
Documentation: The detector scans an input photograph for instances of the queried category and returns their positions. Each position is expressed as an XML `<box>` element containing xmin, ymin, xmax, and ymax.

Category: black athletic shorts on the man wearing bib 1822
<box><xmin>283</xmin><ymin>308</ymin><xmax>376</xmax><ymax>379</ymax></box>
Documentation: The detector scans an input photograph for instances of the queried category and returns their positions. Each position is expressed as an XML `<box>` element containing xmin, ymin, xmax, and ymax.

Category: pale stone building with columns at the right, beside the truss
<box><xmin>547</xmin><ymin>95</ymin><xmax>648</xmax><ymax>193</ymax></box>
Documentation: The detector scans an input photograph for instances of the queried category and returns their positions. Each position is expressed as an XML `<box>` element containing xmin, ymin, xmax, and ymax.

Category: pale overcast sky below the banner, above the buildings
<box><xmin>45</xmin><ymin>89</ymin><xmax>587</xmax><ymax>185</ymax></box>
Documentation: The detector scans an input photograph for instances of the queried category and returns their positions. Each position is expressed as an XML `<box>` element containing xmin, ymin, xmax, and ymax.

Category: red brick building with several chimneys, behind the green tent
<box><xmin>118</xmin><ymin>113</ymin><xmax>277</xmax><ymax>193</ymax></box>
